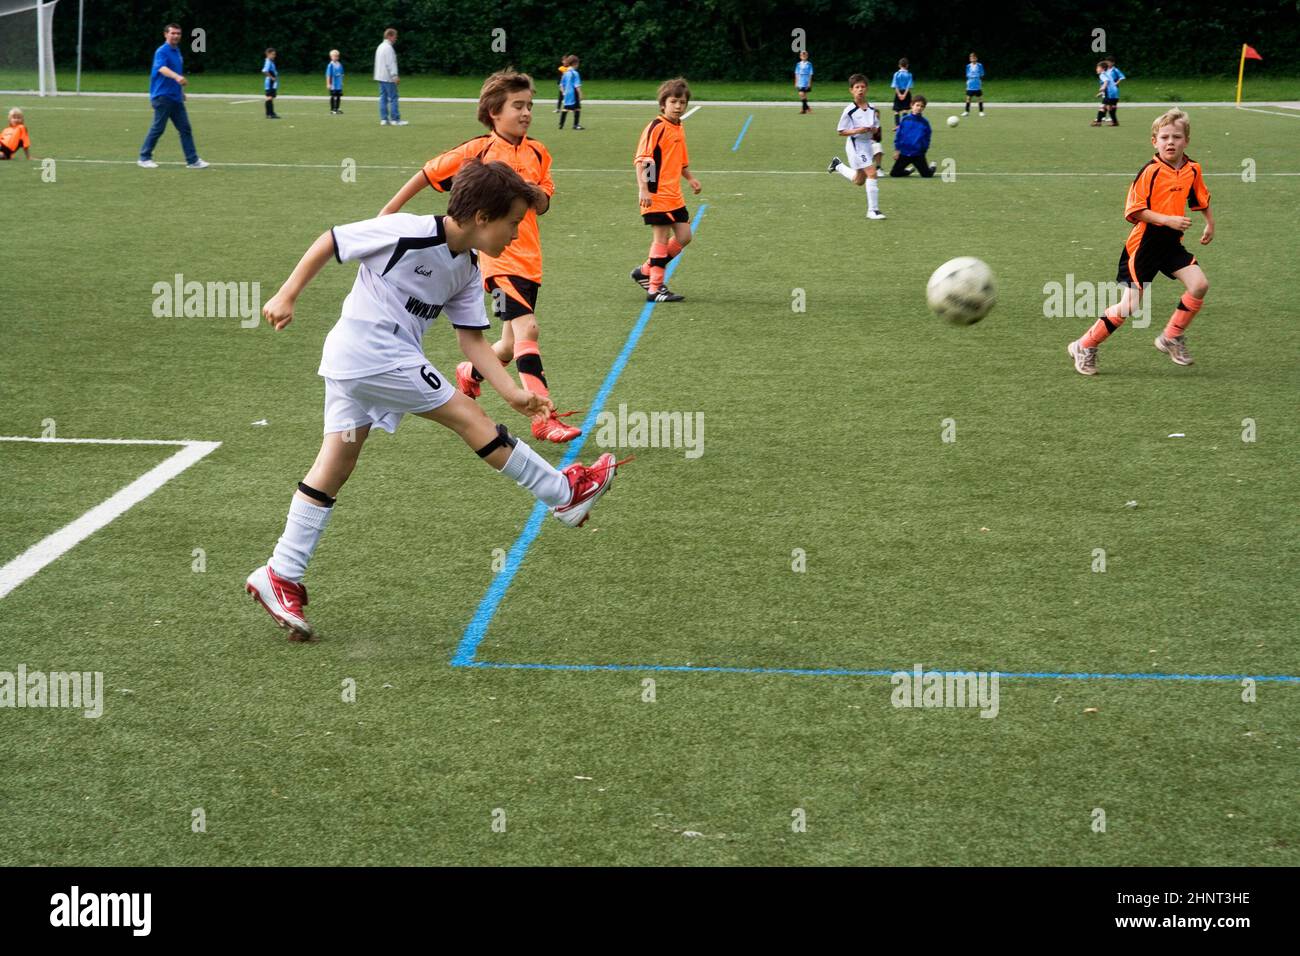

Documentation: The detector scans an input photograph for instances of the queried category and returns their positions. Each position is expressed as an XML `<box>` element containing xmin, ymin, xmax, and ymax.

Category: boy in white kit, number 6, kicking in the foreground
<box><xmin>246</xmin><ymin>160</ymin><xmax>619</xmax><ymax>640</ymax></box>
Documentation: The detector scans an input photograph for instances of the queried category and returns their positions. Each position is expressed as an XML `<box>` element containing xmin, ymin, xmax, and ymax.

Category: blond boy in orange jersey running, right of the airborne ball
<box><xmin>1067</xmin><ymin>109</ymin><xmax>1214</xmax><ymax>375</ymax></box>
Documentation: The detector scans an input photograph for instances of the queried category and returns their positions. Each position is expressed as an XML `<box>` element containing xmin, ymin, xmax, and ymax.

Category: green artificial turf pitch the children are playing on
<box><xmin>0</xmin><ymin>91</ymin><xmax>1300</xmax><ymax>866</ymax></box>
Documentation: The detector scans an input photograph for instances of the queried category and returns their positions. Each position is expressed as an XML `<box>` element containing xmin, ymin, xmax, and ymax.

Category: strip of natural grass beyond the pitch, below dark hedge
<box><xmin>0</xmin><ymin>62</ymin><xmax>1300</xmax><ymax>103</ymax></box>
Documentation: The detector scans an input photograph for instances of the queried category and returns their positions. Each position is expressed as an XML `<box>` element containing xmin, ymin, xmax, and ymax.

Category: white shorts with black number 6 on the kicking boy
<box><xmin>325</xmin><ymin>363</ymin><xmax>456</xmax><ymax>434</ymax></box>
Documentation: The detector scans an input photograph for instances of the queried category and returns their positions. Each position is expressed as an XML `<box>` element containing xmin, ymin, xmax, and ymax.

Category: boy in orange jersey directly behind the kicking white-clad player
<box><xmin>380</xmin><ymin>70</ymin><xmax>582</xmax><ymax>442</ymax></box>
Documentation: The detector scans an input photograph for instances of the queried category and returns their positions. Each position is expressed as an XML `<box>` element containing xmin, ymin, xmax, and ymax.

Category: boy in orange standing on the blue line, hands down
<box><xmin>632</xmin><ymin>77</ymin><xmax>701</xmax><ymax>302</ymax></box>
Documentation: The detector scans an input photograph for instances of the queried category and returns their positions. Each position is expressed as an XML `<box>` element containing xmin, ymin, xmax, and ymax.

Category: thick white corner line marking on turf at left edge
<box><xmin>0</xmin><ymin>436</ymin><xmax>221</xmax><ymax>598</ymax></box>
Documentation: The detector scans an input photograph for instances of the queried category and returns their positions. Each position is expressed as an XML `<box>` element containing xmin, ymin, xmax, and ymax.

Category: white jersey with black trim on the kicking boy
<box><xmin>319</xmin><ymin>212</ymin><xmax>488</xmax><ymax>378</ymax></box>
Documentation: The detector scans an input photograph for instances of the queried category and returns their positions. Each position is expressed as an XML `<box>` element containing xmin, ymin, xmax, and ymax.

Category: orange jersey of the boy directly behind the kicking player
<box><xmin>424</xmin><ymin>133</ymin><xmax>555</xmax><ymax>285</ymax></box>
